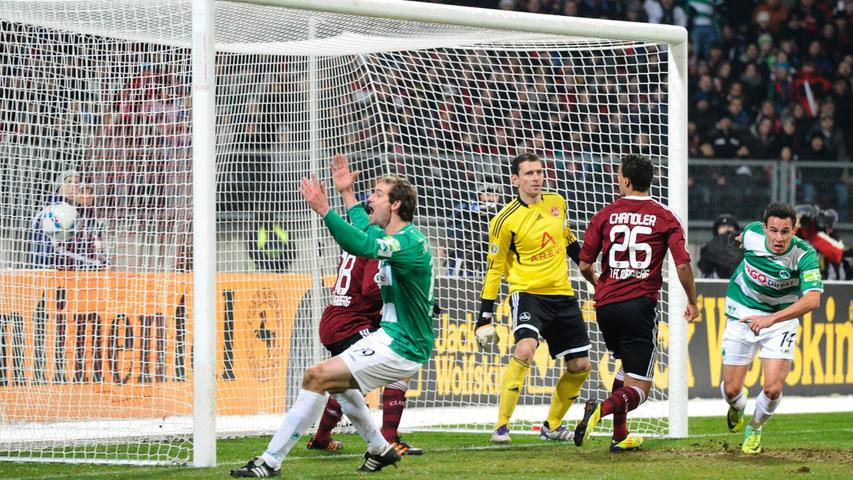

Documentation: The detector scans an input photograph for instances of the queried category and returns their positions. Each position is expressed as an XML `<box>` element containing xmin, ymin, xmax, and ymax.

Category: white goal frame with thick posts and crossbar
<box><xmin>186</xmin><ymin>0</ymin><xmax>687</xmax><ymax>467</ymax></box>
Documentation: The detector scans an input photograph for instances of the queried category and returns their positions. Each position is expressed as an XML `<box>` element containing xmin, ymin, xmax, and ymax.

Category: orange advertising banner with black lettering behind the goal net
<box><xmin>0</xmin><ymin>271</ymin><xmax>311</xmax><ymax>421</ymax></box>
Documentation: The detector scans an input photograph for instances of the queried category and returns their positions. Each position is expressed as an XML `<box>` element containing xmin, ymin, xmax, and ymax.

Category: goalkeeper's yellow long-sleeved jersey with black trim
<box><xmin>480</xmin><ymin>193</ymin><xmax>577</xmax><ymax>300</ymax></box>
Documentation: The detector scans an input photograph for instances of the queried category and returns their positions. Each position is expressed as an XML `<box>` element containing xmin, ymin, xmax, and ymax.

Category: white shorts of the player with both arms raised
<box><xmin>340</xmin><ymin>328</ymin><xmax>421</xmax><ymax>395</ymax></box>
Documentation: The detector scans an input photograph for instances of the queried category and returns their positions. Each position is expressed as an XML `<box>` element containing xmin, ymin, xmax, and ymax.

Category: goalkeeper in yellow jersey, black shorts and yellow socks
<box><xmin>476</xmin><ymin>153</ymin><xmax>596</xmax><ymax>443</ymax></box>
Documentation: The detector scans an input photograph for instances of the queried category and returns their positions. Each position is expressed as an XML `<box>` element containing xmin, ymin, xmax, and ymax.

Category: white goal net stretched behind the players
<box><xmin>0</xmin><ymin>0</ymin><xmax>686</xmax><ymax>463</ymax></box>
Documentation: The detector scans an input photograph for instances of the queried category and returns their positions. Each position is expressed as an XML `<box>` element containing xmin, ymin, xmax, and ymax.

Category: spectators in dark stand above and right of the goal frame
<box><xmin>490</xmin><ymin>0</ymin><xmax>853</xmax><ymax>222</ymax></box>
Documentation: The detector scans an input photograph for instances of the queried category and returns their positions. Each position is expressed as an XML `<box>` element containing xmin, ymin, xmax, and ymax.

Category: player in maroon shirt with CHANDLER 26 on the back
<box><xmin>574</xmin><ymin>155</ymin><xmax>699</xmax><ymax>452</ymax></box>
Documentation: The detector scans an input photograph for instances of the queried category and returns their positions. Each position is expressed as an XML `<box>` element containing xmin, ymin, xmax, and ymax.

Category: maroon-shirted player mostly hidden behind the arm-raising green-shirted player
<box><xmin>308</xmin><ymin>252</ymin><xmax>424</xmax><ymax>455</ymax></box>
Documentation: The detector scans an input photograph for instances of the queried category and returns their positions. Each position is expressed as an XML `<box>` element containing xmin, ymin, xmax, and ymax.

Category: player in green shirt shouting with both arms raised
<box><xmin>231</xmin><ymin>156</ymin><xmax>435</xmax><ymax>477</ymax></box>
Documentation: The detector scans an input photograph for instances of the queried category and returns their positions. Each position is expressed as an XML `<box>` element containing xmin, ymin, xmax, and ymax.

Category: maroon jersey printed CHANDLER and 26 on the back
<box><xmin>581</xmin><ymin>196</ymin><xmax>690</xmax><ymax>307</ymax></box>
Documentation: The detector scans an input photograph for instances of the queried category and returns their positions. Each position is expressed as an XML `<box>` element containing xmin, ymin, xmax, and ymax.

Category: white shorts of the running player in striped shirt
<box><xmin>722</xmin><ymin>318</ymin><xmax>800</xmax><ymax>365</ymax></box>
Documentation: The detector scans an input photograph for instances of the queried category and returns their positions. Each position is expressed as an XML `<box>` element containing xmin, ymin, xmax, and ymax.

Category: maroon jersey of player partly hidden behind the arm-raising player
<box><xmin>320</xmin><ymin>252</ymin><xmax>382</xmax><ymax>345</ymax></box>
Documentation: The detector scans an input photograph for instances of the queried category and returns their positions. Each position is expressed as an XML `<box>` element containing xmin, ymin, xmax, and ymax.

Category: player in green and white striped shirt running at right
<box><xmin>720</xmin><ymin>202</ymin><xmax>823</xmax><ymax>454</ymax></box>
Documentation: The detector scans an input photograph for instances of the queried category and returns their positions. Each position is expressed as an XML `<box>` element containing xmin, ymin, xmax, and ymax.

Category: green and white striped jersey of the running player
<box><xmin>726</xmin><ymin>222</ymin><xmax>823</xmax><ymax>320</ymax></box>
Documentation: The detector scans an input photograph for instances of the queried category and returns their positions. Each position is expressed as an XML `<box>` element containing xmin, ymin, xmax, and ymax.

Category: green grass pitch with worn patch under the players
<box><xmin>0</xmin><ymin>412</ymin><xmax>853</xmax><ymax>480</ymax></box>
